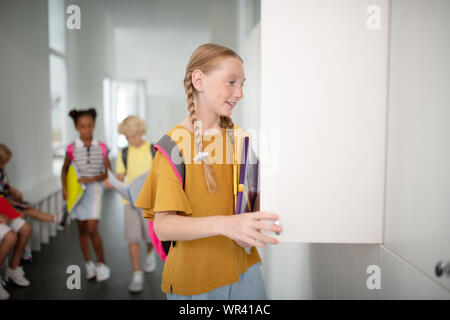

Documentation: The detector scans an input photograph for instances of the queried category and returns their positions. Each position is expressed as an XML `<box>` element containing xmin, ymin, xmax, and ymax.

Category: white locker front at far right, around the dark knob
<box><xmin>385</xmin><ymin>0</ymin><xmax>450</xmax><ymax>296</ymax></box>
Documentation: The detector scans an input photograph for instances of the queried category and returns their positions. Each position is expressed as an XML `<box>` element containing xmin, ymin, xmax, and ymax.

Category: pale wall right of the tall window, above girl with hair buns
<box><xmin>66</xmin><ymin>0</ymin><xmax>115</xmax><ymax>141</ymax></box>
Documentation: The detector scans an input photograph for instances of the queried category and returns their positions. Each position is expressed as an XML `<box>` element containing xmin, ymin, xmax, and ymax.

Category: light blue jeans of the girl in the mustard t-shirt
<box><xmin>167</xmin><ymin>263</ymin><xmax>267</xmax><ymax>300</ymax></box>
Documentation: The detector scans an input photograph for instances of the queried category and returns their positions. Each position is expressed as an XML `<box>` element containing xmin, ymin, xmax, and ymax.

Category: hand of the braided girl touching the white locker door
<box><xmin>221</xmin><ymin>211</ymin><xmax>282</xmax><ymax>248</ymax></box>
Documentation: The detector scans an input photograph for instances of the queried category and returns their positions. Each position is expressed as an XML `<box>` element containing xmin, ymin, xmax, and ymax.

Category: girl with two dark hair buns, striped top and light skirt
<box><xmin>61</xmin><ymin>108</ymin><xmax>110</xmax><ymax>281</ymax></box>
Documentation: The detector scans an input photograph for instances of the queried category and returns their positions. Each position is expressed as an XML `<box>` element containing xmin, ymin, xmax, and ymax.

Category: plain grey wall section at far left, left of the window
<box><xmin>0</xmin><ymin>0</ymin><xmax>53</xmax><ymax>190</ymax></box>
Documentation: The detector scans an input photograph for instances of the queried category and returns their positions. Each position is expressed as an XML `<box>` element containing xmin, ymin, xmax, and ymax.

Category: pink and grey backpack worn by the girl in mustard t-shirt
<box><xmin>148</xmin><ymin>126</ymin><xmax>234</xmax><ymax>261</ymax></box>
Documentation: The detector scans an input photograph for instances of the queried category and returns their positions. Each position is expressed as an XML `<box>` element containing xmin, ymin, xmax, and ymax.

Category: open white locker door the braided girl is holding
<box><xmin>258</xmin><ymin>0</ymin><xmax>389</xmax><ymax>243</ymax></box>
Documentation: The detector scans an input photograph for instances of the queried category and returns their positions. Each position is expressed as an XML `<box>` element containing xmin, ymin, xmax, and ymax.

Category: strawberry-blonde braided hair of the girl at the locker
<box><xmin>184</xmin><ymin>43</ymin><xmax>243</xmax><ymax>193</ymax></box>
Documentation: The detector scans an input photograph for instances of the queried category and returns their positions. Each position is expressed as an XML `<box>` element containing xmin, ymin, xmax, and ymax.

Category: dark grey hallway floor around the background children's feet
<box><xmin>3</xmin><ymin>190</ymin><xmax>165</xmax><ymax>300</ymax></box>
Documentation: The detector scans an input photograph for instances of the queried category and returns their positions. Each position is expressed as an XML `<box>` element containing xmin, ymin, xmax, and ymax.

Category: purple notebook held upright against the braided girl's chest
<box><xmin>236</xmin><ymin>137</ymin><xmax>259</xmax><ymax>214</ymax></box>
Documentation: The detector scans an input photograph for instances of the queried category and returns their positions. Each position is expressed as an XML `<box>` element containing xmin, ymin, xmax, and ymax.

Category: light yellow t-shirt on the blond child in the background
<box><xmin>116</xmin><ymin>141</ymin><xmax>153</xmax><ymax>204</ymax></box>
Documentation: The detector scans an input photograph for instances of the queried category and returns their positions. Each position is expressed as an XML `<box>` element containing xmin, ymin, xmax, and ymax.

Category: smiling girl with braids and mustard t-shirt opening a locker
<box><xmin>136</xmin><ymin>43</ymin><xmax>281</xmax><ymax>299</ymax></box>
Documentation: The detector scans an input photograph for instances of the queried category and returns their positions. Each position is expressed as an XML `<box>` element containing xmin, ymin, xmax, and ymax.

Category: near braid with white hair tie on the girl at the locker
<box><xmin>184</xmin><ymin>72</ymin><xmax>218</xmax><ymax>193</ymax></box>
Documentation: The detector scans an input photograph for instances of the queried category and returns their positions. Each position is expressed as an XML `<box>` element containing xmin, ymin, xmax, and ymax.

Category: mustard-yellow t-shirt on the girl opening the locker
<box><xmin>135</xmin><ymin>125</ymin><xmax>261</xmax><ymax>295</ymax></box>
